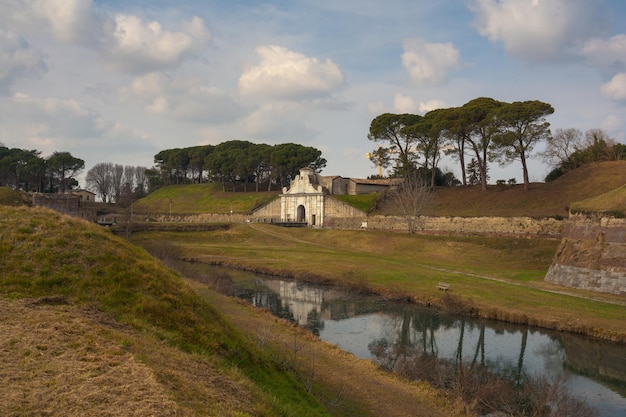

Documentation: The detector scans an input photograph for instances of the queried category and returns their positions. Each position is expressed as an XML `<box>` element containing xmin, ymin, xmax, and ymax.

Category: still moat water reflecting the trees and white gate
<box><xmin>171</xmin><ymin>264</ymin><xmax>626</xmax><ymax>417</ymax></box>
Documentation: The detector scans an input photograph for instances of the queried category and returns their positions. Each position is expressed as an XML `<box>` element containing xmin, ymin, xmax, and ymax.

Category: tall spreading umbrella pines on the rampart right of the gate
<box><xmin>368</xmin><ymin>97</ymin><xmax>554</xmax><ymax>190</ymax></box>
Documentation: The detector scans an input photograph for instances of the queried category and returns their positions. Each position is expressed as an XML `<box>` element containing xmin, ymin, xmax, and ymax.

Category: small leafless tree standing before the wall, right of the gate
<box><xmin>394</xmin><ymin>173</ymin><xmax>432</xmax><ymax>233</ymax></box>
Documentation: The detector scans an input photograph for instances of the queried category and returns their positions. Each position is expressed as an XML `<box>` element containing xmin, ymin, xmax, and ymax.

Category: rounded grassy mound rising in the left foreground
<box><xmin>0</xmin><ymin>206</ymin><xmax>327</xmax><ymax>416</ymax></box>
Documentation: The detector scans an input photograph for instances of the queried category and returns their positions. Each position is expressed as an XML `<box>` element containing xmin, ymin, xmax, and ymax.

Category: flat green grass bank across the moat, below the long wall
<box><xmin>132</xmin><ymin>224</ymin><xmax>626</xmax><ymax>343</ymax></box>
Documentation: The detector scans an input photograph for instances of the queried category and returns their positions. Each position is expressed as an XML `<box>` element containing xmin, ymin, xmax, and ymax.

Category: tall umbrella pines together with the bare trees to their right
<box><xmin>368</xmin><ymin>97</ymin><xmax>626</xmax><ymax>190</ymax></box>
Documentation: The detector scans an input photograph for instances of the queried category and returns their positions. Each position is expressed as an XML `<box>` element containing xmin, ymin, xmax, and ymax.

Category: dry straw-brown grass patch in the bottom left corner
<box><xmin>0</xmin><ymin>298</ymin><xmax>254</xmax><ymax>417</ymax></box>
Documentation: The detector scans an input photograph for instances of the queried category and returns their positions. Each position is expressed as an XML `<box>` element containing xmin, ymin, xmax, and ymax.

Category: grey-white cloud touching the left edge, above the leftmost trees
<box><xmin>0</xmin><ymin>29</ymin><xmax>46</xmax><ymax>95</ymax></box>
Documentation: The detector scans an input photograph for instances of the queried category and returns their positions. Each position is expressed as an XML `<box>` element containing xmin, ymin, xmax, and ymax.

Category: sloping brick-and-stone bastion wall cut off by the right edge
<box><xmin>545</xmin><ymin>215</ymin><xmax>626</xmax><ymax>295</ymax></box>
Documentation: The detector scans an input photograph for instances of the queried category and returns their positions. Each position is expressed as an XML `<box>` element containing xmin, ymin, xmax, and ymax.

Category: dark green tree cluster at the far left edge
<box><xmin>0</xmin><ymin>143</ymin><xmax>85</xmax><ymax>193</ymax></box>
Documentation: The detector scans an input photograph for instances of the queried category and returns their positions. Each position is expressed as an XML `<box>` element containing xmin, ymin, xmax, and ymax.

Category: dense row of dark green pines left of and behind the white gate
<box><xmin>146</xmin><ymin>140</ymin><xmax>326</xmax><ymax>191</ymax></box>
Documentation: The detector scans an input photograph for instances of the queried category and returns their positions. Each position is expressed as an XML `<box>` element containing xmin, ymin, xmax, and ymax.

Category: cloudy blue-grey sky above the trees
<box><xmin>0</xmin><ymin>0</ymin><xmax>626</xmax><ymax>186</ymax></box>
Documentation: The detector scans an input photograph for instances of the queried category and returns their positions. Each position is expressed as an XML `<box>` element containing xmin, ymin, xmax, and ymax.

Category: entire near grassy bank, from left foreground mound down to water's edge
<box><xmin>0</xmin><ymin>206</ymin><xmax>454</xmax><ymax>417</ymax></box>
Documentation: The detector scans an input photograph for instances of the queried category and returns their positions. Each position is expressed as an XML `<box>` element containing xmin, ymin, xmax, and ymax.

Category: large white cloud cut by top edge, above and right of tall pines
<box><xmin>470</xmin><ymin>0</ymin><xmax>604</xmax><ymax>61</ymax></box>
